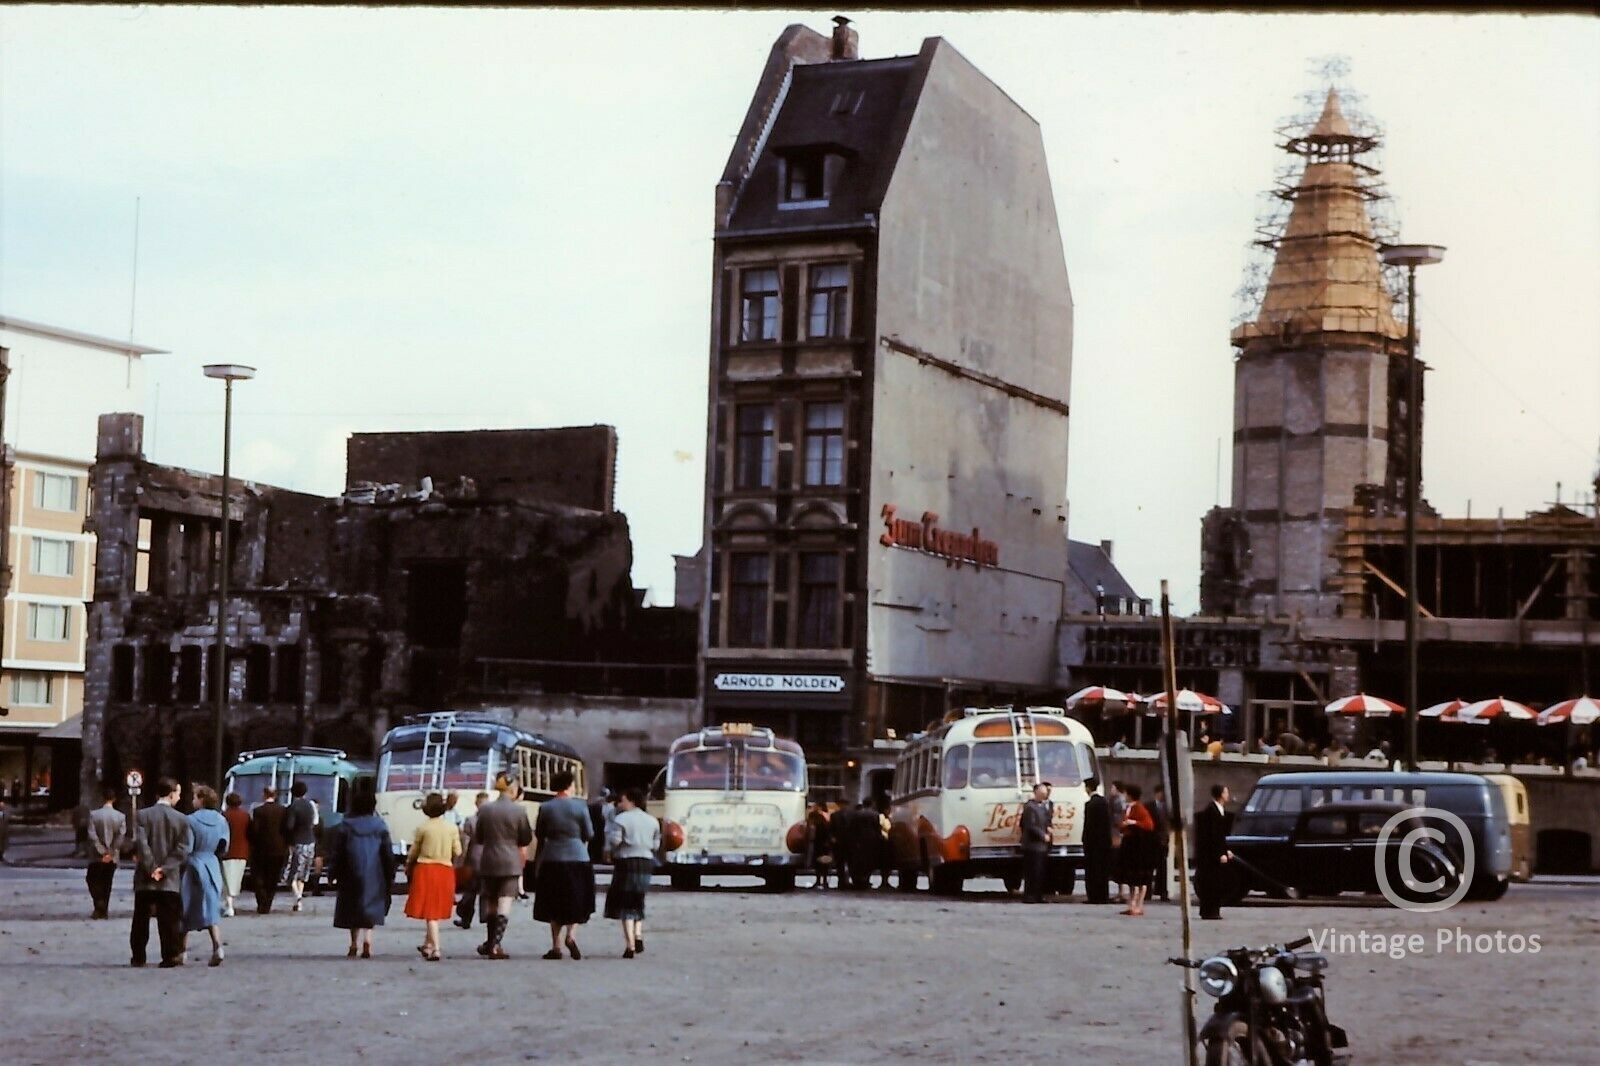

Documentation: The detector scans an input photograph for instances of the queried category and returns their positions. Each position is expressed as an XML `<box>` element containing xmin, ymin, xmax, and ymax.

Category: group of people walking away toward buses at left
<box><xmin>73</xmin><ymin>771</ymin><xmax>661</xmax><ymax>968</ymax></box>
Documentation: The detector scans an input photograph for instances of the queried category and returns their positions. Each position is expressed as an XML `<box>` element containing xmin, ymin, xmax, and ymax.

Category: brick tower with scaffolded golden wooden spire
<box><xmin>1200</xmin><ymin>90</ymin><xmax>1406</xmax><ymax>618</ymax></box>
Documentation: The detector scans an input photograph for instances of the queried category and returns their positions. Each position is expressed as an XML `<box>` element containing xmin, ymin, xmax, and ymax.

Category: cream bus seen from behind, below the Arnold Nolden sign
<box><xmin>650</xmin><ymin>722</ymin><xmax>806</xmax><ymax>892</ymax></box>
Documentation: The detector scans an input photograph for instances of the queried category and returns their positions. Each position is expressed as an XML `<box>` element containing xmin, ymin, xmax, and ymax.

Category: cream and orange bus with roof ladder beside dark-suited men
<box><xmin>890</xmin><ymin>707</ymin><xmax>1099</xmax><ymax>896</ymax></box>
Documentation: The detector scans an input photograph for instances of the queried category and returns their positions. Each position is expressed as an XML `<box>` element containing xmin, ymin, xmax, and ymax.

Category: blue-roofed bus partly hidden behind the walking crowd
<box><xmin>378</xmin><ymin>711</ymin><xmax>587</xmax><ymax>858</ymax></box>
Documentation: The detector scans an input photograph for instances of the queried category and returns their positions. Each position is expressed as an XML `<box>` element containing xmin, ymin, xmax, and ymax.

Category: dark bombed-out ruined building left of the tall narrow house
<box><xmin>82</xmin><ymin>415</ymin><xmax>637</xmax><ymax>795</ymax></box>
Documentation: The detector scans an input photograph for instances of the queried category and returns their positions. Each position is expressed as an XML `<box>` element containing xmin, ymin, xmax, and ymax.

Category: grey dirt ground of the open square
<box><xmin>0</xmin><ymin>869</ymin><xmax>1600</xmax><ymax>1066</ymax></box>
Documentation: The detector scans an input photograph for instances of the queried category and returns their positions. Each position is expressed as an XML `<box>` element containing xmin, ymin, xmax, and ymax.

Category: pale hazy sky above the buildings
<box><xmin>0</xmin><ymin>5</ymin><xmax>1600</xmax><ymax>613</ymax></box>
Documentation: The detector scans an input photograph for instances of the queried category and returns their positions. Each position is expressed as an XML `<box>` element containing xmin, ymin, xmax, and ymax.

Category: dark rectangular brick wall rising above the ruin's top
<box><xmin>346</xmin><ymin>426</ymin><xmax>616</xmax><ymax>511</ymax></box>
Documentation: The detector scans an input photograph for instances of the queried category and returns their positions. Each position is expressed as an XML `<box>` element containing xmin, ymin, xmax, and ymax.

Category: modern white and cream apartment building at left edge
<box><xmin>0</xmin><ymin>315</ymin><xmax>160</xmax><ymax>797</ymax></box>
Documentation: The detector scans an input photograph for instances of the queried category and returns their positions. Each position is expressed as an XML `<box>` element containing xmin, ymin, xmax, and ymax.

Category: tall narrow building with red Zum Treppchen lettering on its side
<box><xmin>701</xmin><ymin>19</ymin><xmax>1072</xmax><ymax>792</ymax></box>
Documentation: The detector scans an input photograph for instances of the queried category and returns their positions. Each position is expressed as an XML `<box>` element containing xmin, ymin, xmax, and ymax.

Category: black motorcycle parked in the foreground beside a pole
<box><xmin>1168</xmin><ymin>936</ymin><xmax>1350</xmax><ymax>1066</ymax></box>
